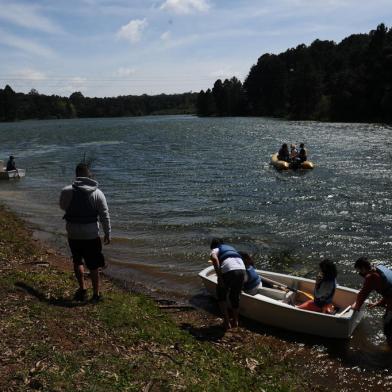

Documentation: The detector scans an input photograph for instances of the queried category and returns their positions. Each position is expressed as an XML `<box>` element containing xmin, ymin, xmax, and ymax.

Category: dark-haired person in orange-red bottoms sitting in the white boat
<box><xmin>297</xmin><ymin>259</ymin><xmax>338</xmax><ymax>313</ymax></box>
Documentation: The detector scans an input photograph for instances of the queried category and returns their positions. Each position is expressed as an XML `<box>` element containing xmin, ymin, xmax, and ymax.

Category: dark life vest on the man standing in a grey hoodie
<box><xmin>63</xmin><ymin>188</ymin><xmax>98</xmax><ymax>224</ymax></box>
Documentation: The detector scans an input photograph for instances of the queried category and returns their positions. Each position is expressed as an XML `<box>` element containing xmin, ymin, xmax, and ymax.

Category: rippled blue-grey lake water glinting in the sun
<box><xmin>0</xmin><ymin>116</ymin><xmax>392</xmax><ymax>362</ymax></box>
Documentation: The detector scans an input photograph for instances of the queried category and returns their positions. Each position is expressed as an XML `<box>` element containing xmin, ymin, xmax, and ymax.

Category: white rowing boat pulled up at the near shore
<box><xmin>199</xmin><ymin>266</ymin><xmax>363</xmax><ymax>339</ymax></box>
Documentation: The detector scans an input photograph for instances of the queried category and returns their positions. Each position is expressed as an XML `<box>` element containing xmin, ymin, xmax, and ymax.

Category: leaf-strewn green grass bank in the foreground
<box><xmin>0</xmin><ymin>205</ymin><xmax>311</xmax><ymax>392</ymax></box>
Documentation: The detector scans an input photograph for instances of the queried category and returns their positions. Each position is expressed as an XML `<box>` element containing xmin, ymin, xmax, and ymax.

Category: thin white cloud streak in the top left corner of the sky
<box><xmin>0</xmin><ymin>1</ymin><xmax>61</xmax><ymax>33</ymax></box>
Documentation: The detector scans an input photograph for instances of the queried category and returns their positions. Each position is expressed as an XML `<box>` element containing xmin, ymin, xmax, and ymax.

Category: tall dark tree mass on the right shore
<box><xmin>197</xmin><ymin>24</ymin><xmax>392</xmax><ymax>123</ymax></box>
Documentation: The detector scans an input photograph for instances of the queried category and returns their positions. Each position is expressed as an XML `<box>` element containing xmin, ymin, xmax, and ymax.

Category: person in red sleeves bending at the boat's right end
<box><xmin>351</xmin><ymin>257</ymin><xmax>392</xmax><ymax>347</ymax></box>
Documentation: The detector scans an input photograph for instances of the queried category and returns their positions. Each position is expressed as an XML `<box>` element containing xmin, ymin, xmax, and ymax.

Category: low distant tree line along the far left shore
<box><xmin>0</xmin><ymin>85</ymin><xmax>197</xmax><ymax>121</ymax></box>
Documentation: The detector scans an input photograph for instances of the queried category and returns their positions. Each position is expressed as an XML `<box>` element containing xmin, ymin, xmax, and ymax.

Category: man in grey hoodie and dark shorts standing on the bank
<box><xmin>60</xmin><ymin>163</ymin><xmax>111</xmax><ymax>302</ymax></box>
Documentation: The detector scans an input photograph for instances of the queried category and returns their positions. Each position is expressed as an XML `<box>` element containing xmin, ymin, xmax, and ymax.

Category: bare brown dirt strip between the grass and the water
<box><xmin>0</xmin><ymin>206</ymin><xmax>392</xmax><ymax>392</ymax></box>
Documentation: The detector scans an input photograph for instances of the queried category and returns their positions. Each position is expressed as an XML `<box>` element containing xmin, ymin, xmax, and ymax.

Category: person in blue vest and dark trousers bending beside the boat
<box><xmin>210</xmin><ymin>238</ymin><xmax>245</xmax><ymax>329</ymax></box>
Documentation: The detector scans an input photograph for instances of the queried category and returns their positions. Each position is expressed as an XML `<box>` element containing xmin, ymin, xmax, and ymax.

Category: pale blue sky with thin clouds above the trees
<box><xmin>0</xmin><ymin>0</ymin><xmax>392</xmax><ymax>97</ymax></box>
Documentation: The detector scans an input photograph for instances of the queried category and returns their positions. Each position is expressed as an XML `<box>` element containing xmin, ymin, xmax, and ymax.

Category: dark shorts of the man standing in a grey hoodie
<box><xmin>68</xmin><ymin>237</ymin><xmax>105</xmax><ymax>270</ymax></box>
